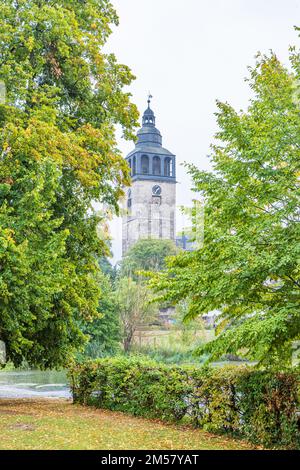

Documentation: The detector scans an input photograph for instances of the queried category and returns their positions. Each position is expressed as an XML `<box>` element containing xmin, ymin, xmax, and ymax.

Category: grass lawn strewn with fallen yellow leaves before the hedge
<box><xmin>0</xmin><ymin>399</ymin><xmax>252</xmax><ymax>450</ymax></box>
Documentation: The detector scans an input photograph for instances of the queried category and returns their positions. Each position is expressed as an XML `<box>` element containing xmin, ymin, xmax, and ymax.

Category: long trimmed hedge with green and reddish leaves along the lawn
<box><xmin>69</xmin><ymin>357</ymin><xmax>300</xmax><ymax>449</ymax></box>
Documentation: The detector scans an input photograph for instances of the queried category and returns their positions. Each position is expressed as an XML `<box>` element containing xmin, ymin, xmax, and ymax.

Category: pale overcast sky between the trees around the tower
<box><xmin>106</xmin><ymin>0</ymin><xmax>300</xmax><ymax>261</ymax></box>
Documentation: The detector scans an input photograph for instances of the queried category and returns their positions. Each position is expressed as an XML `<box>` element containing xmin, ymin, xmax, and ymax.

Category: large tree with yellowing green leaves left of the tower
<box><xmin>0</xmin><ymin>0</ymin><xmax>138</xmax><ymax>367</ymax></box>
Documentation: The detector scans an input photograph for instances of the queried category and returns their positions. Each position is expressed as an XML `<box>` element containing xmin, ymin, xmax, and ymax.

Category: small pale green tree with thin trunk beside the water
<box><xmin>116</xmin><ymin>277</ymin><xmax>158</xmax><ymax>352</ymax></box>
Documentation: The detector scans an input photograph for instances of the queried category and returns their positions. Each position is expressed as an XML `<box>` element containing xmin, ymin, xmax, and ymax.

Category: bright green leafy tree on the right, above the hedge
<box><xmin>151</xmin><ymin>52</ymin><xmax>300</xmax><ymax>365</ymax></box>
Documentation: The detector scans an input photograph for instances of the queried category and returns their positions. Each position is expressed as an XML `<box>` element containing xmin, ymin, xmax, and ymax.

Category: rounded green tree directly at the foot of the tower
<box><xmin>120</xmin><ymin>239</ymin><xmax>177</xmax><ymax>279</ymax></box>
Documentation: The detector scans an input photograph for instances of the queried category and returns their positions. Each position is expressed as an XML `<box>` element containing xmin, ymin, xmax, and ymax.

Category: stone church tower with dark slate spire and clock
<box><xmin>122</xmin><ymin>96</ymin><xmax>176</xmax><ymax>255</ymax></box>
